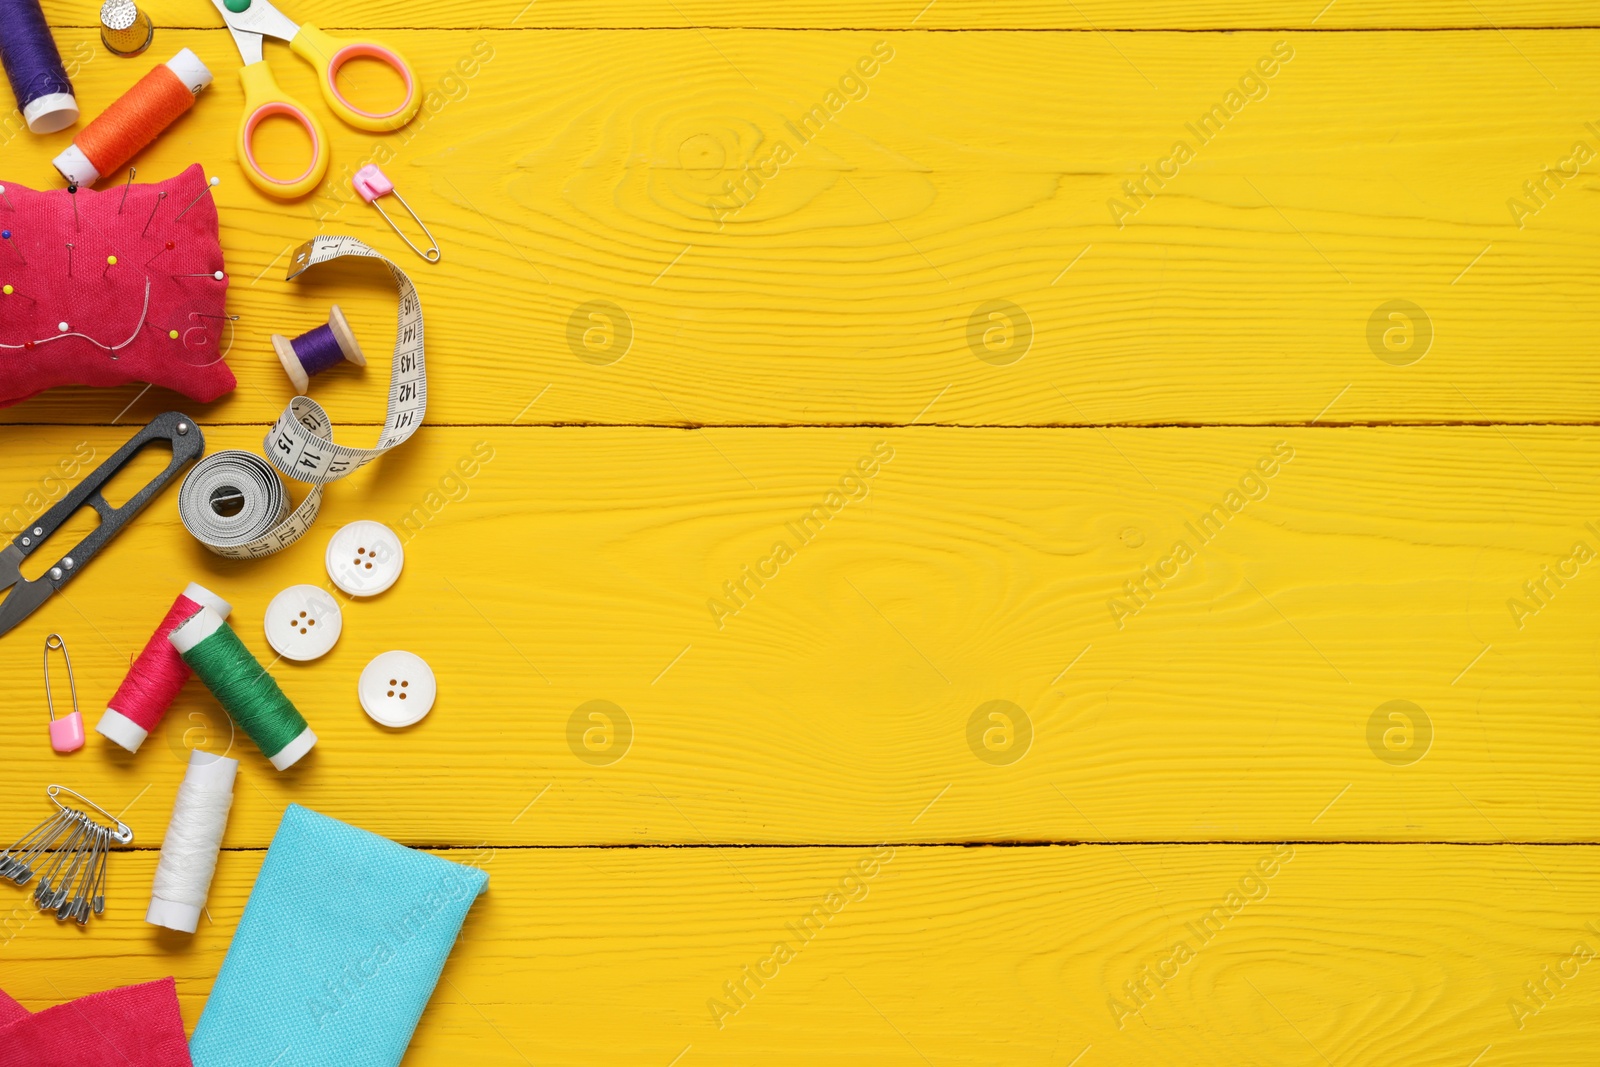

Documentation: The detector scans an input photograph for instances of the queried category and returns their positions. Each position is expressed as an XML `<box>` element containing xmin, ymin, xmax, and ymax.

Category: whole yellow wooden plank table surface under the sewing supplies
<box><xmin>0</xmin><ymin>0</ymin><xmax>1600</xmax><ymax>1067</ymax></box>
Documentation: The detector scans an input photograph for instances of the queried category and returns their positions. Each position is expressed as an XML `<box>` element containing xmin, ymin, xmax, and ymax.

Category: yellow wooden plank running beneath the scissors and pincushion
<box><xmin>0</xmin><ymin>27</ymin><xmax>1600</xmax><ymax>424</ymax></box>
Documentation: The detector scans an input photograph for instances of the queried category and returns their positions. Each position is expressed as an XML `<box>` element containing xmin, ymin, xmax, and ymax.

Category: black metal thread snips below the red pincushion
<box><xmin>0</xmin><ymin>411</ymin><xmax>205</xmax><ymax>635</ymax></box>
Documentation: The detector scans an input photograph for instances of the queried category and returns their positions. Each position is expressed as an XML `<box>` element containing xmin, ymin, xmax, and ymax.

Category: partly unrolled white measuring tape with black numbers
<box><xmin>178</xmin><ymin>237</ymin><xmax>427</xmax><ymax>560</ymax></box>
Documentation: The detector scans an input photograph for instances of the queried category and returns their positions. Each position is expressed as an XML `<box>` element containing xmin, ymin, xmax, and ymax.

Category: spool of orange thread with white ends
<box><xmin>54</xmin><ymin>48</ymin><xmax>211</xmax><ymax>186</ymax></box>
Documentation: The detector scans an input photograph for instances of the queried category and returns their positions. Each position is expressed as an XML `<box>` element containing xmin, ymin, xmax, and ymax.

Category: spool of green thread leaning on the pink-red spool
<box><xmin>166</xmin><ymin>608</ymin><xmax>317</xmax><ymax>771</ymax></box>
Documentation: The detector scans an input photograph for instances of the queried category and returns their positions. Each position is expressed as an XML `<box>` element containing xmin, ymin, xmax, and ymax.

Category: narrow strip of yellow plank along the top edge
<box><xmin>31</xmin><ymin>0</ymin><xmax>1597</xmax><ymax>30</ymax></box>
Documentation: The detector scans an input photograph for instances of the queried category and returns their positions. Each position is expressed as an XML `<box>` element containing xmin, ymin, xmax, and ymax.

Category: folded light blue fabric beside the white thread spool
<box><xmin>189</xmin><ymin>805</ymin><xmax>488</xmax><ymax>1067</ymax></box>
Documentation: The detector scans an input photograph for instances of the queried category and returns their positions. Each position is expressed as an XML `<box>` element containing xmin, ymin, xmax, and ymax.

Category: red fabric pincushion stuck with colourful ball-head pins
<box><xmin>0</xmin><ymin>165</ymin><xmax>235</xmax><ymax>406</ymax></box>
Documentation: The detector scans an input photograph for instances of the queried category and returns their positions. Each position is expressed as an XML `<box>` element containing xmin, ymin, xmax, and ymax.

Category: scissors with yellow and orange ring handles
<box><xmin>211</xmin><ymin>0</ymin><xmax>422</xmax><ymax>200</ymax></box>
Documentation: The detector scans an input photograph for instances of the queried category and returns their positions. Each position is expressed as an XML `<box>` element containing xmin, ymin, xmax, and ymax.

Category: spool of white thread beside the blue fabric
<box><xmin>144</xmin><ymin>749</ymin><xmax>238</xmax><ymax>934</ymax></box>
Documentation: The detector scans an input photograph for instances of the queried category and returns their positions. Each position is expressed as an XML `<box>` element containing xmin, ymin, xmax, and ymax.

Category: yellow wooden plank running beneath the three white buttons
<box><xmin>0</xmin><ymin>422</ymin><xmax>1600</xmax><ymax>846</ymax></box>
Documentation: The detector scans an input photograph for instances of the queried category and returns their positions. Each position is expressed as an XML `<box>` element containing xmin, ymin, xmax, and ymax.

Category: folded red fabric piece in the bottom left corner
<box><xmin>0</xmin><ymin>977</ymin><xmax>194</xmax><ymax>1067</ymax></box>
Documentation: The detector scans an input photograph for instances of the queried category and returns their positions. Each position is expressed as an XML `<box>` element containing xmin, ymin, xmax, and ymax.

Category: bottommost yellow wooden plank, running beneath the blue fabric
<box><xmin>0</xmin><ymin>845</ymin><xmax>1600</xmax><ymax>1067</ymax></box>
